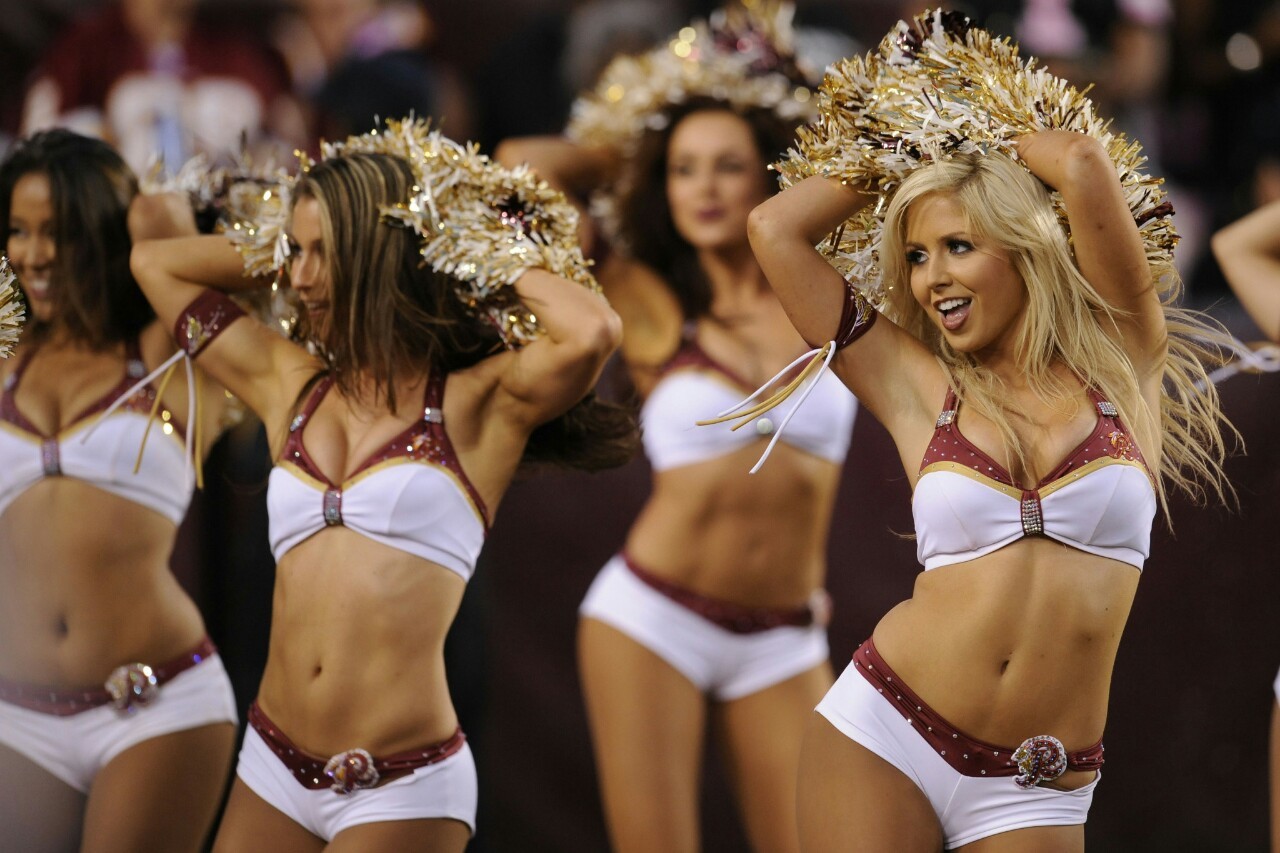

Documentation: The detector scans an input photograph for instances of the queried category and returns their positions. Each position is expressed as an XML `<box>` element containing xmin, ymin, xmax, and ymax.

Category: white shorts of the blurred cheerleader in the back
<box><xmin>579</xmin><ymin>555</ymin><xmax>831</xmax><ymax>701</ymax></box>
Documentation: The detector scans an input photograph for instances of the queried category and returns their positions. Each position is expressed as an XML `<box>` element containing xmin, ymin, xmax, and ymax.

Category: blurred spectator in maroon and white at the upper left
<box><xmin>22</xmin><ymin>0</ymin><xmax>306</xmax><ymax>169</ymax></box>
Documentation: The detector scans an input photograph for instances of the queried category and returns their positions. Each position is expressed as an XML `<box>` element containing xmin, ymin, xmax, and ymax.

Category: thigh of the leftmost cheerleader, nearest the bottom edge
<box><xmin>83</xmin><ymin>722</ymin><xmax>236</xmax><ymax>853</ymax></box>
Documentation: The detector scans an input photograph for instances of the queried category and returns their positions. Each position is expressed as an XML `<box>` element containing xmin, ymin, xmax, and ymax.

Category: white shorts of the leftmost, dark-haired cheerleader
<box><xmin>0</xmin><ymin>654</ymin><xmax>237</xmax><ymax>794</ymax></box>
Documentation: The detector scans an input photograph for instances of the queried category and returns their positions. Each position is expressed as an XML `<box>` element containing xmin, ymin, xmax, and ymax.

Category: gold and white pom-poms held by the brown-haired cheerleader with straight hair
<box><xmin>224</xmin><ymin>118</ymin><xmax>600</xmax><ymax>347</ymax></box>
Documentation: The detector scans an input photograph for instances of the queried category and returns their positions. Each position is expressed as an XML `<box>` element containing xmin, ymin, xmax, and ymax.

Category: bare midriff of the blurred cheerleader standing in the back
<box><xmin>626</xmin><ymin>442</ymin><xmax>840</xmax><ymax>607</ymax></box>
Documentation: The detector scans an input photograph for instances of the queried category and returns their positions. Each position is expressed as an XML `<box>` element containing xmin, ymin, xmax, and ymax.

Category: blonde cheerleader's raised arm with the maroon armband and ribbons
<box><xmin>748</xmin><ymin>177</ymin><xmax>945</xmax><ymax>435</ymax></box>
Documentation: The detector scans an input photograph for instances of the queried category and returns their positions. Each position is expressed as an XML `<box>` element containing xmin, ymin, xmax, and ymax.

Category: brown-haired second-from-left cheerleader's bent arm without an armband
<box><xmin>494</xmin><ymin>269</ymin><xmax>622</xmax><ymax>433</ymax></box>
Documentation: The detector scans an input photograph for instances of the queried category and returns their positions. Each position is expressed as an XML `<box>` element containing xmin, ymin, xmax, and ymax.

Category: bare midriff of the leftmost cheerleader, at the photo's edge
<box><xmin>0</xmin><ymin>476</ymin><xmax>205</xmax><ymax>688</ymax></box>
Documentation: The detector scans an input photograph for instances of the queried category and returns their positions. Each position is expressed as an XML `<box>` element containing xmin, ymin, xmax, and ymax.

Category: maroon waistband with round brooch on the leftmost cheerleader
<box><xmin>0</xmin><ymin>637</ymin><xmax>218</xmax><ymax>717</ymax></box>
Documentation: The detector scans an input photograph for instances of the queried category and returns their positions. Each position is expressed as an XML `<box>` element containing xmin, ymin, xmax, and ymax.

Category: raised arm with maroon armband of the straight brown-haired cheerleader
<box><xmin>129</xmin><ymin>196</ymin><xmax>321</xmax><ymax>435</ymax></box>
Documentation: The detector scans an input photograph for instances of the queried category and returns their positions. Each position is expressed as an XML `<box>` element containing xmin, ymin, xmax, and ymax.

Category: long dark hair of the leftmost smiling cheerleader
<box><xmin>0</xmin><ymin>129</ymin><xmax>146</xmax><ymax>350</ymax></box>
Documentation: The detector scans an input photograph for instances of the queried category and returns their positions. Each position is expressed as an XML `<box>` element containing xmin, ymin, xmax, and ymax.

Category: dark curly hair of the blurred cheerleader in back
<box><xmin>618</xmin><ymin>99</ymin><xmax>799</xmax><ymax>319</ymax></box>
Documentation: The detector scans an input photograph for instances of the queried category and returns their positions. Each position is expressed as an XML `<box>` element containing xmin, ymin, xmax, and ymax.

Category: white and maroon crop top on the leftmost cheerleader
<box><xmin>0</xmin><ymin>341</ymin><xmax>191</xmax><ymax>524</ymax></box>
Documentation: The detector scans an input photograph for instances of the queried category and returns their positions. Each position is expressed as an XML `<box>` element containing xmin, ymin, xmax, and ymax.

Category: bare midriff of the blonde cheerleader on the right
<box><xmin>874</xmin><ymin>537</ymin><xmax>1140</xmax><ymax>751</ymax></box>
